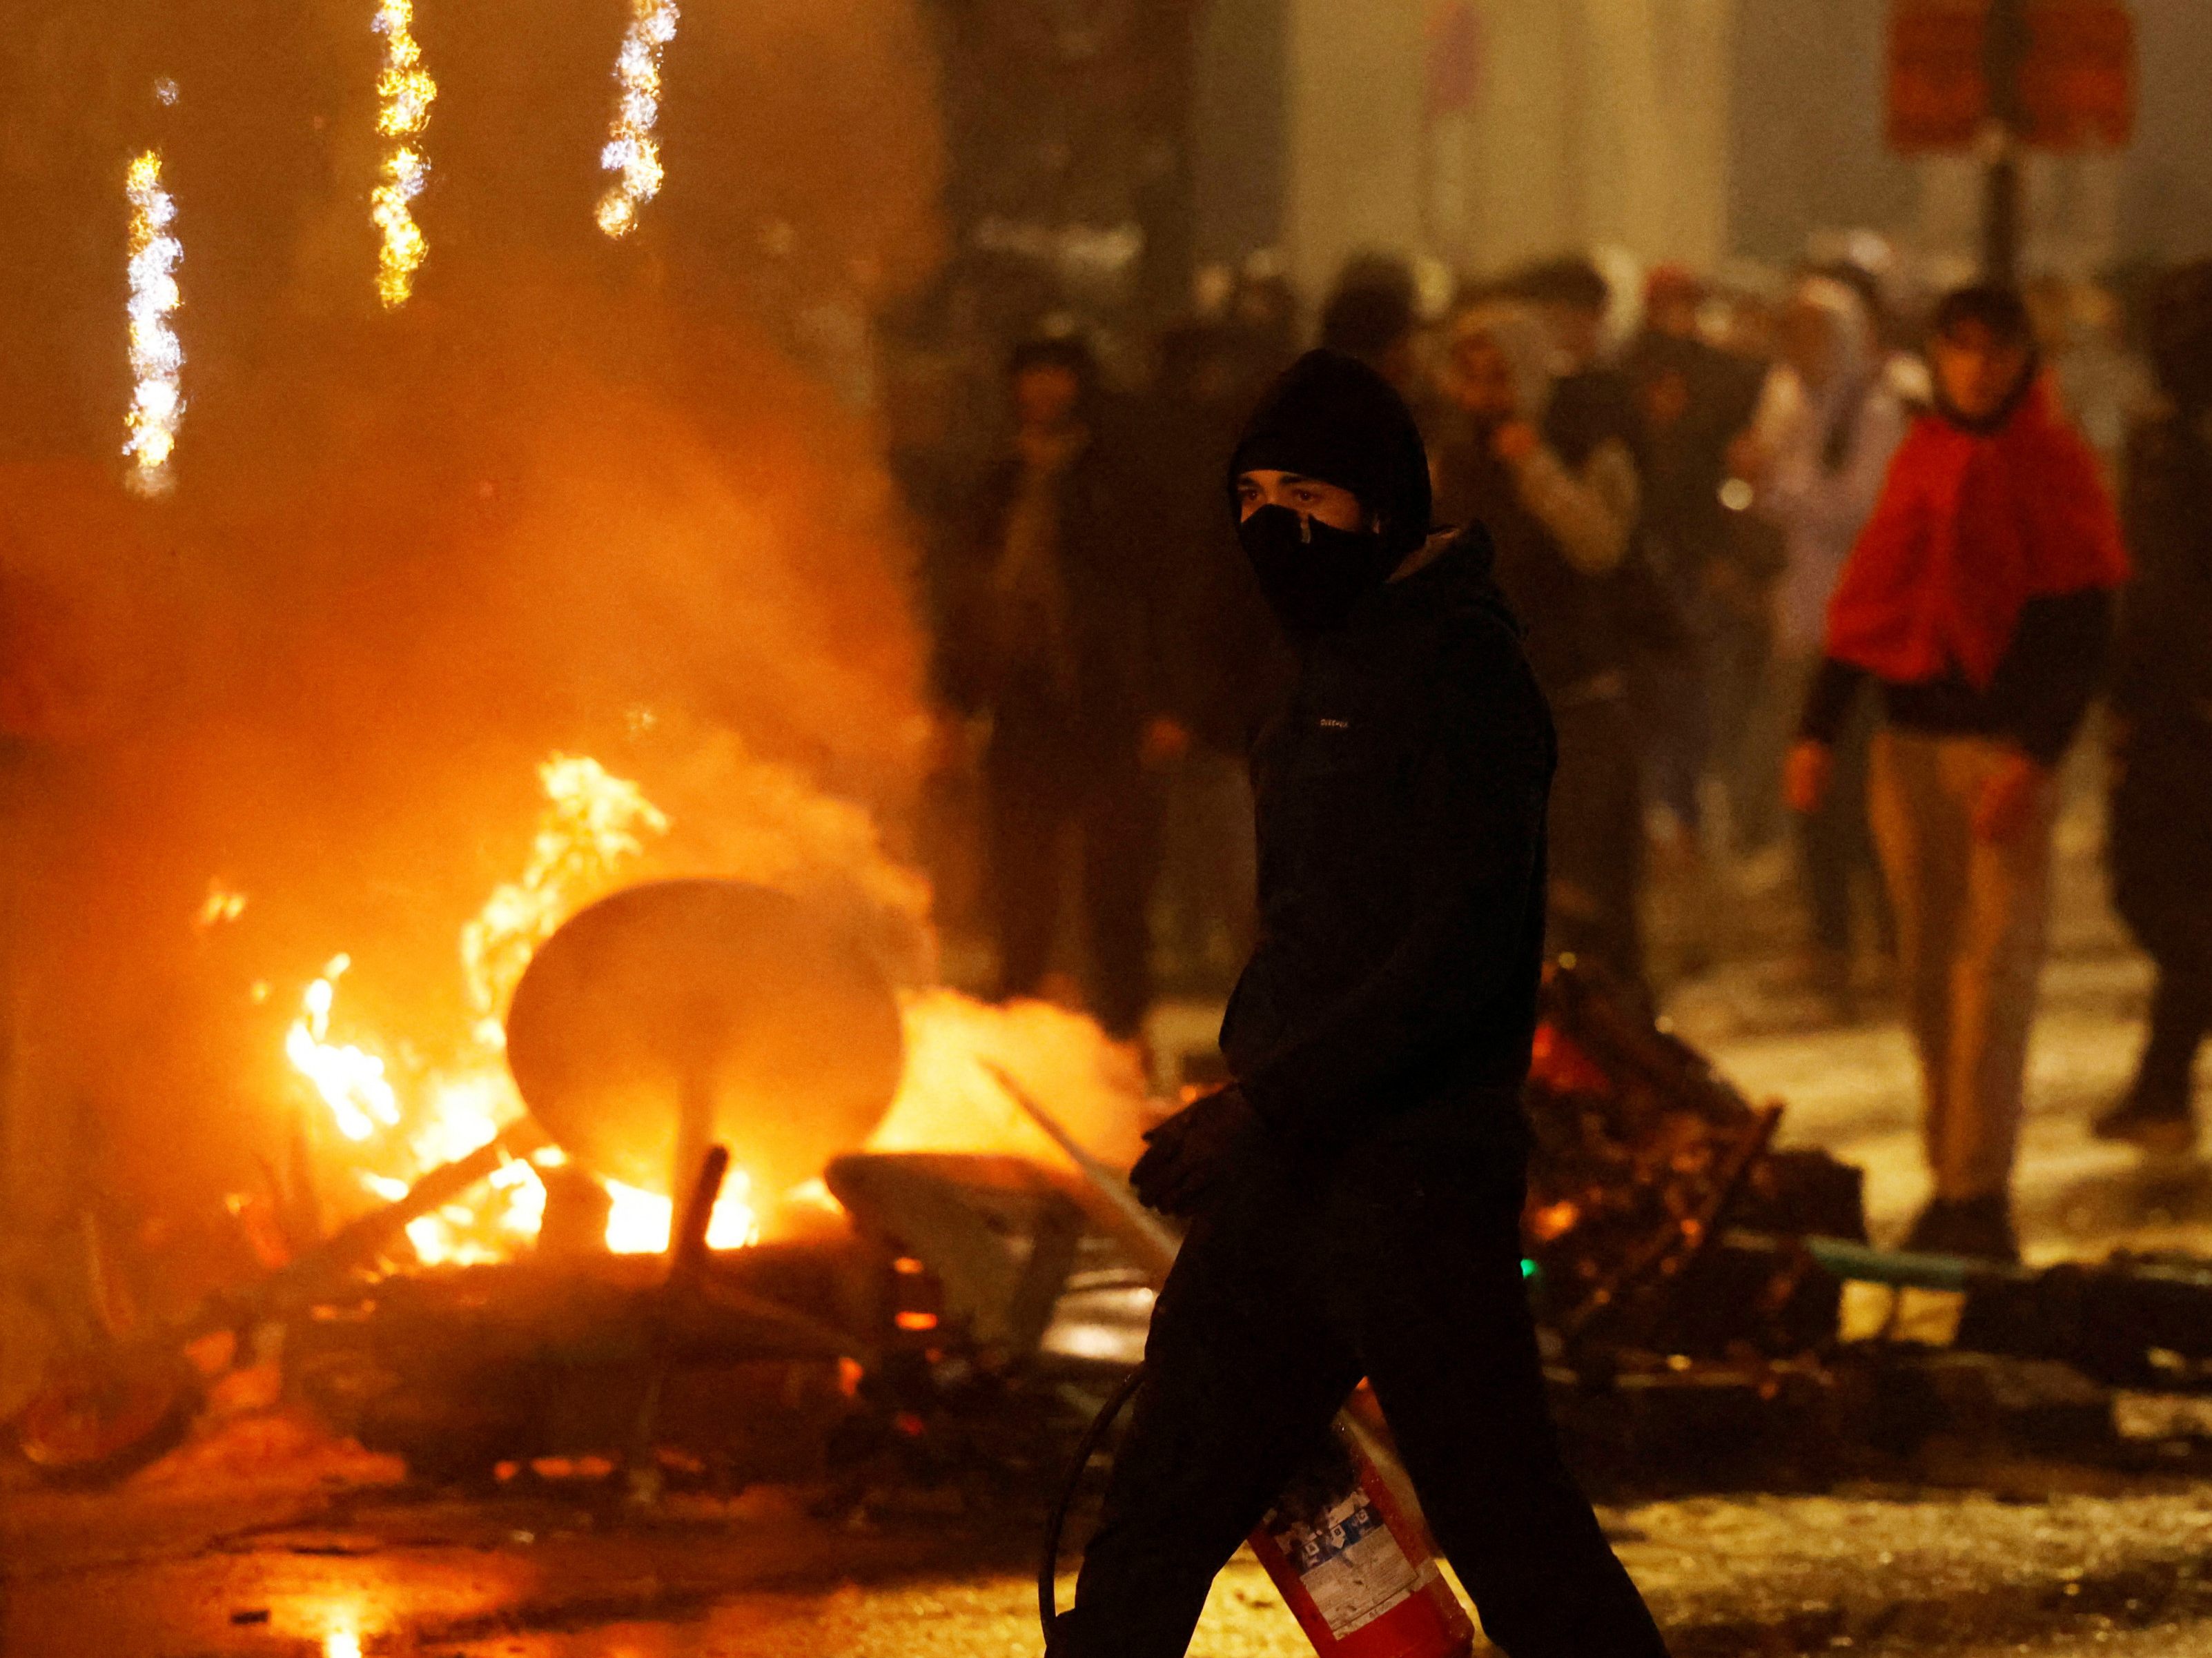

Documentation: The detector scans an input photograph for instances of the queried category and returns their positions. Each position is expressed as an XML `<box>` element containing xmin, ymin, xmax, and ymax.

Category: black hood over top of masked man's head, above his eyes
<box><xmin>1228</xmin><ymin>351</ymin><xmax>1429</xmax><ymax>553</ymax></box>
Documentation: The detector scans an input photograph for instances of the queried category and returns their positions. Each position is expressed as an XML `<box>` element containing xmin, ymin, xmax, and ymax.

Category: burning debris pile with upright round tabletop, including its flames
<box><xmin>13</xmin><ymin>800</ymin><xmax>1148</xmax><ymax>1479</ymax></box>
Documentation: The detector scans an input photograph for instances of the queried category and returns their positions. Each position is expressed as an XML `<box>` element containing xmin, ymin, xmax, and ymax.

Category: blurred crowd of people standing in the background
<box><xmin>894</xmin><ymin>239</ymin><xmax>2212</xmax><ymax>1256</ymax></box>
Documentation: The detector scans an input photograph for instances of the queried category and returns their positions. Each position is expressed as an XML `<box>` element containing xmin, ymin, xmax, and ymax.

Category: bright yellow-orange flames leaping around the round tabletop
<box><xmin>285</xmin><ymin>754</ymin><xmax>1144</xmax><ymax>1262</ymax></box>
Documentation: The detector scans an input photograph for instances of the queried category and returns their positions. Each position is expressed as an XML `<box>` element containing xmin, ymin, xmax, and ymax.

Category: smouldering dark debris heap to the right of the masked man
<box><xmin>1526</xmin><ymin>962</ymin><xmax>2212</xmax><ymax>1486</ymax></box>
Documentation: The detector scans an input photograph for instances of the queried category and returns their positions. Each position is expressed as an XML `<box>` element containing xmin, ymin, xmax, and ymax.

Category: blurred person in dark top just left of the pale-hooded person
<box><xmin>1621</xmin><ymin>265</ymin><xmax>1765</xmax><ymax>875</ymax></box>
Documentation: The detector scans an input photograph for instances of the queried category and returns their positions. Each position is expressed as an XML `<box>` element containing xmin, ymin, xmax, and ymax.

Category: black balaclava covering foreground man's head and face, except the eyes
<box><xmin>1228</xmin><ymin>351</ymin><xmax>1429</xmax><ymax>639</ymax></box>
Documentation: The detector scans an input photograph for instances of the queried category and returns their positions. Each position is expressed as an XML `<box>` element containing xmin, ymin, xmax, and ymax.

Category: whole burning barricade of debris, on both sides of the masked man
<box><xmin>15</xmin><ymin>875</ymin><xmax>2212</xmax><ymax>1503</ymax></box>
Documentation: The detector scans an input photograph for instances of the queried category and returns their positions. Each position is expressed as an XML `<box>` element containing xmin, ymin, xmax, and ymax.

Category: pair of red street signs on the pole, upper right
<box><xmin>1887</xmin><ymin>0</ymin><xmax>2135</xmax><ymax>152</ymax></box>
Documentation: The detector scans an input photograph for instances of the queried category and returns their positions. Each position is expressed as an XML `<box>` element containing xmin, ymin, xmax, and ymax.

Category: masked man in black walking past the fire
<box><xmin>1050</xmin><ymin>351</ymin><xmax>1663</xmax><ymax>1658</ymax></box>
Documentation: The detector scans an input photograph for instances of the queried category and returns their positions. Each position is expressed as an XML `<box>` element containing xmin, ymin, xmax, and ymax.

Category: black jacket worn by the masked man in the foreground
<box><xmin>1221</xmin><ymin>529</ymin><xmax>1555</xmax><ymax>1143</ymax></box>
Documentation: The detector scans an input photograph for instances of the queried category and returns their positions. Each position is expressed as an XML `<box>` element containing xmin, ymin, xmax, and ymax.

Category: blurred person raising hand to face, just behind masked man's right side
<box><xmin>1433</xmin><ymin>301</ymin><xmax>1648</xmax><ymax>995</ymax></box>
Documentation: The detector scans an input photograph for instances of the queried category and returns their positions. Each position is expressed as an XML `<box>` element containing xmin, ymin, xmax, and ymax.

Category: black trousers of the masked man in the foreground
<box><xmin>1053</xmin><ymin>1094</ymin><xmax>1665</xmax><ymax>1658</ymax></box>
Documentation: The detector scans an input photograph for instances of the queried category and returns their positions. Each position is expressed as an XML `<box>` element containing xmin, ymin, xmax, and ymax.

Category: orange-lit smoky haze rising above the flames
<box><xmin>0</xmin><ymin>0</ymin><xmax>938</xmax><ymax>1212</ymax></box>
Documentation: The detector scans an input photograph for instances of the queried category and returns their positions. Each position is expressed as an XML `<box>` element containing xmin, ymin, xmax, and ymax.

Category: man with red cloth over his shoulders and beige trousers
<box><xmin>1788</xmin><ymin>288</ymin><xmax>2128</xmax><ymax>1260</ymax></box>
